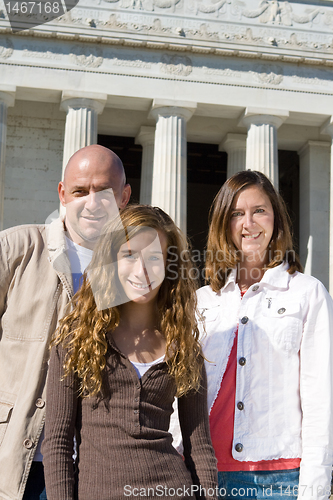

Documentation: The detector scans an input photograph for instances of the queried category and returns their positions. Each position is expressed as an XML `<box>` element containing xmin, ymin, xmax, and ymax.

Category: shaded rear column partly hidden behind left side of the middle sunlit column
<box><xmin>135</xmin><ymin>126</ymin><xmax>155</xmax><ymax>205</ymax></box>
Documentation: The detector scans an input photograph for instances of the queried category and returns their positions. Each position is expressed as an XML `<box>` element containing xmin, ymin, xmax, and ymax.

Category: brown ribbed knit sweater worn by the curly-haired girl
<box><xmin>42</xmin><ymin>337</ymin><xmax>217</xmax><ymax>500</ymax></box>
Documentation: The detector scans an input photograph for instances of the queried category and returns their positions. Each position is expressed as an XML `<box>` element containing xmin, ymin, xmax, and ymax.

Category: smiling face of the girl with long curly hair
<box><xmin>117</xmin><ymin>228</ymin><xmax>167</xmax><ymax>304</ymax></box>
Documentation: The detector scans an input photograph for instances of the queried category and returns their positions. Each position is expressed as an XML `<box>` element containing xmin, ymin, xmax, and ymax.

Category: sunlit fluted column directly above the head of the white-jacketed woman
<box><xmin>239</xmin><ymin>108</ymin><xmax>289</xmax><ymax>189</ymax></box>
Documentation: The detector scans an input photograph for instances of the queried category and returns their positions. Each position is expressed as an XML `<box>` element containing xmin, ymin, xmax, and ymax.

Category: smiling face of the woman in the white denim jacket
<box><xmin>230</xmin><ymin>186</ymin><xmax>274</xmax><ymax>262</ymax></box>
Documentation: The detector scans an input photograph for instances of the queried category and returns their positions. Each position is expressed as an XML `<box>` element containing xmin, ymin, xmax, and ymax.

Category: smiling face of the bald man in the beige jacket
<box><xmin>58</xmin><ymin>155</ymin><xmax>130</xmax><ymax>249</ymax></box>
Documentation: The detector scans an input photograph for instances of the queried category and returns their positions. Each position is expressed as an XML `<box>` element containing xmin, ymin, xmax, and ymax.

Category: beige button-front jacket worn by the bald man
<box><xmin>0</xmin><ymin>219</ymin><xmax>73</xmax><ymax>500</ymax></box>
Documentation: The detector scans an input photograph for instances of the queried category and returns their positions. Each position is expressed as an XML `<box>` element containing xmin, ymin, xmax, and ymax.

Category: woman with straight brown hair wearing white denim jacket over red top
<box><xmin>198</xmin><ymin>171</ymin><xmax>333</xmax><ymax>499</ymax></box>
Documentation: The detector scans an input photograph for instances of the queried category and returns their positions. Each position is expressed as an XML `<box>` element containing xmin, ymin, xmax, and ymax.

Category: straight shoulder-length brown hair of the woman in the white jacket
<box><xmin>206</xmin><ymin>170</ymin><xmax>302</xmax><ymax>292</ymax></box>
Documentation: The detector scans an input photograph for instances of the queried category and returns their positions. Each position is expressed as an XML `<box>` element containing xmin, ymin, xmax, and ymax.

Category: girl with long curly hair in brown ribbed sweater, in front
<box><xmin>43</xmin><ymin>205</ymin><xmax>216</xmax><ymax>500</ymax></box>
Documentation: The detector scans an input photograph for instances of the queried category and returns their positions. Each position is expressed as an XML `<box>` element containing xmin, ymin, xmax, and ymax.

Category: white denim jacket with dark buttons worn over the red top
<box><xmin>198</xmin><ymin>264</ymin><xmax>333</xmax><ymax>500</ymax></box>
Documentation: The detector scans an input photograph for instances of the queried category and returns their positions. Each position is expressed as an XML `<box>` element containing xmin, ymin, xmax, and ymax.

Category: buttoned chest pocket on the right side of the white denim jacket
<box><xmin>262</xmin><ymin>299</ymin><xmax>303</xmax><ymax>352</ymax></box>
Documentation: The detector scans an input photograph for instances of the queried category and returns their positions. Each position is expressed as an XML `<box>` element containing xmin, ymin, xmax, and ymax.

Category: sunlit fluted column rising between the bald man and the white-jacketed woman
<box><xmin>150</xmin><ymin>99</ymin><xmax>197</xmax><ymax>233</ymax></box>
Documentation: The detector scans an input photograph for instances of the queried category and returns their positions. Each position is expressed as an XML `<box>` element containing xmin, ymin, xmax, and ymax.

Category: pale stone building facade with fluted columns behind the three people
<box><xmin>0</xmin><ymin>0</ymin><xmax>333</xmax><ymax>292</ymax></box>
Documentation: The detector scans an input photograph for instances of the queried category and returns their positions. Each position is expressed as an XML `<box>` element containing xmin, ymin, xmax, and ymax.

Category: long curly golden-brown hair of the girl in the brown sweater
<box><xmin>52</xmin><ymin>205</ymin><xmax>203</xmax><ymax>398</ymax></box>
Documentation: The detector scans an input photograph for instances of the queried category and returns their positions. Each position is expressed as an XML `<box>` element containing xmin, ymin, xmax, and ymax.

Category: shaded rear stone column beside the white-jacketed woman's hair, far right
<box><xmin>298</xmin><ymin>141</ymin><xmax>330</xmax><ymax>289</ymax></box>
